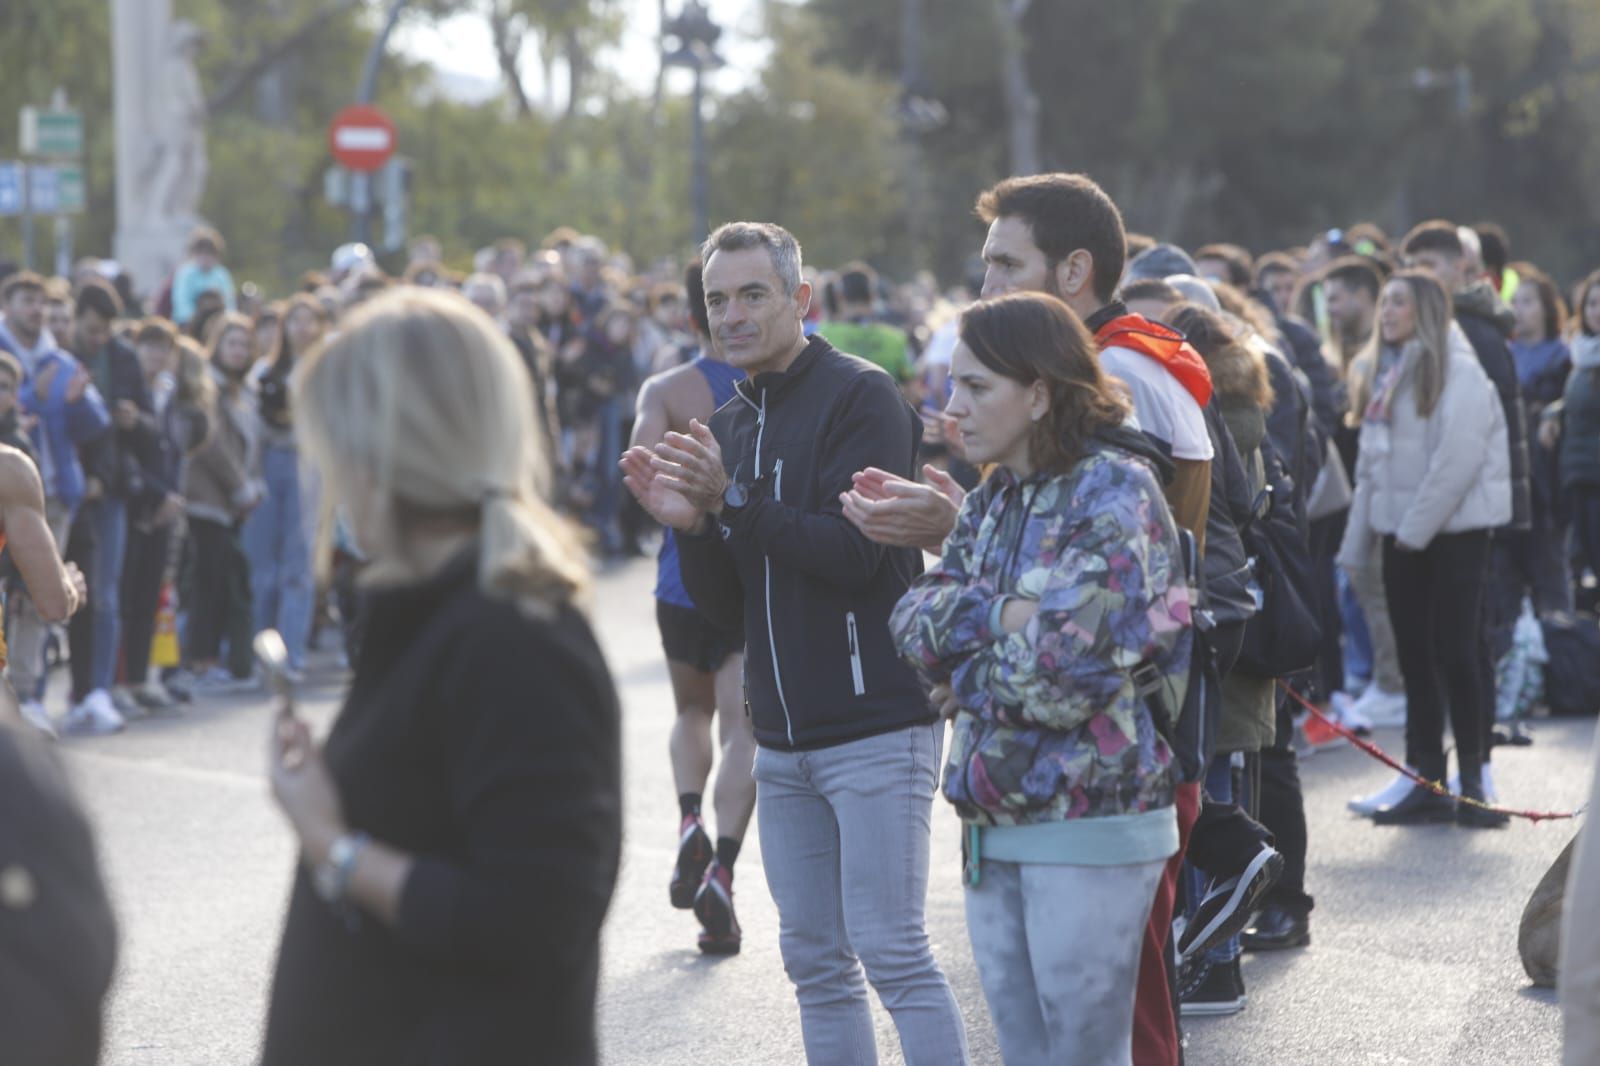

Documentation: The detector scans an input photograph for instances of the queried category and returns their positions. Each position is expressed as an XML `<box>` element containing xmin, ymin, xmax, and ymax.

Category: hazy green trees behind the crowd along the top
<box><xmin>0</xmin><ymin>0</ymin><xmax>1600</xmax><ymax>291</ymax></box>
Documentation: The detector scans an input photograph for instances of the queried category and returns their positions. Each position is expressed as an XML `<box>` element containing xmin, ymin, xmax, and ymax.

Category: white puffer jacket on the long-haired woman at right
<box><xmin>1339</xmin><ymin>323</ymin><xmax>1512</xmax><ymax>568</ymax></box>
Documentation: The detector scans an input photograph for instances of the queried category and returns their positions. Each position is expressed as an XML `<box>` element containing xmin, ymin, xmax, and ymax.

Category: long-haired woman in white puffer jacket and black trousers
<box><xmin>1341</xmin><ymin>271</ymin><xmax>1512</xmax><ymax>828</ymax></box>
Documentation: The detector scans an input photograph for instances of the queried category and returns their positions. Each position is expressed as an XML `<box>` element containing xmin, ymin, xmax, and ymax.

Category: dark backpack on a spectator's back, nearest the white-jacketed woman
<box><xmin>1234</xmin><ymin>442</ymin><xmax>1322</xmax><ymax>677</ymax></box>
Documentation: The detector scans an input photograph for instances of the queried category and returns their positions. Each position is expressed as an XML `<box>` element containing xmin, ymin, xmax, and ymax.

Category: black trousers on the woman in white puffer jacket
<box><xmin>1384</xmin><ymin>530</ymin><xmax>1494</xmax><ymax>781</ymax></box>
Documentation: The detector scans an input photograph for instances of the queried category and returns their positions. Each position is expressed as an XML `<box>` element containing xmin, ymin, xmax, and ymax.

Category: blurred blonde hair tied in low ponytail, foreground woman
<box><xmin>293</xmin><ymin>287</ymin><xmax>589</xmax><ymax>611</ymax></box>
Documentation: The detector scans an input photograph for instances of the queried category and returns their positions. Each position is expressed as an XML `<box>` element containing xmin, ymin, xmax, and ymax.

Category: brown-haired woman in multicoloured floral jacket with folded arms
<box><xmin>890</xmin><ymin>293</ymin><xmax>1190</xmax><ymax>1064</ymax></box>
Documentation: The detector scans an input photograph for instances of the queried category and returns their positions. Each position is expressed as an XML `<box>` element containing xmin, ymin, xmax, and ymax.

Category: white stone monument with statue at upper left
<box><xmin>112</xmin><ymin>0</ymin><xmax>206</xmax><ymax>293</ymax></box>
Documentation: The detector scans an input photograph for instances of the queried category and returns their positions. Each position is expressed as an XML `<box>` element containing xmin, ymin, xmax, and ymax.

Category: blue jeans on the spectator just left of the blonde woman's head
<box><xmin>245</xmin><ymin>445</ymin><xmax>315</xmax><ymax>669</ymax></box>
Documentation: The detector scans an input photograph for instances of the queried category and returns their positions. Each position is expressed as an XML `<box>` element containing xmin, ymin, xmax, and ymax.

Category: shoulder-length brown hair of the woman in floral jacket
<box><xmin>960</xmin><ymin>293</ymin><xmax>1130</xmax><ymax>474</ymax></box>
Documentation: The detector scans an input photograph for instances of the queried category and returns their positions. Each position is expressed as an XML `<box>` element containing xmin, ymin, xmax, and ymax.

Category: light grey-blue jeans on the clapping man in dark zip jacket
<box><xmin>755</xmin><ymin>725</ymin><xmax>966</xmax><ymax>1066</ymax></box>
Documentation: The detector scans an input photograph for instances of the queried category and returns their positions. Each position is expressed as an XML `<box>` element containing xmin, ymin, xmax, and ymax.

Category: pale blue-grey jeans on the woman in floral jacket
<box><xmin>966</xmin><ymin>860</ymin><xmax>1166</xmax><ymax>1066</ymax></box>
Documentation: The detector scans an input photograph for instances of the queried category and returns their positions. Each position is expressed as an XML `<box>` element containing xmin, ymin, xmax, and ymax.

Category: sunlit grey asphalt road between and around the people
<box><xmin>53</xmin><ymin>550</ymin><xmax>1594</xmax><ymax>1066</ymax></box>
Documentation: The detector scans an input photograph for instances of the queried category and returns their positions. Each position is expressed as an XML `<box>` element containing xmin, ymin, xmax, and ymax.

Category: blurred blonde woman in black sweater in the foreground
<box><xmin>262</xmin><ymin>288</ymin><xmax>621</xmax><ymax>1066</ymax></box>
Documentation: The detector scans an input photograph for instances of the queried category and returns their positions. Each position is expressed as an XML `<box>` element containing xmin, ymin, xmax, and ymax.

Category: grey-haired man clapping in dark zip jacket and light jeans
<box><xmin>622</xmin><ymin>222</ymin><xmax>966</xmax><ymax>1063</ymax></box>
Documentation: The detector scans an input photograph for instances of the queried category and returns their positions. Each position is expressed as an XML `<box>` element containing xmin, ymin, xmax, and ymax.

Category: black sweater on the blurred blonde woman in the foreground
<box><xmin>262</xmin><ymin>550</ymin><xmax>621</xmax><ymax>1066</ymax></box>
